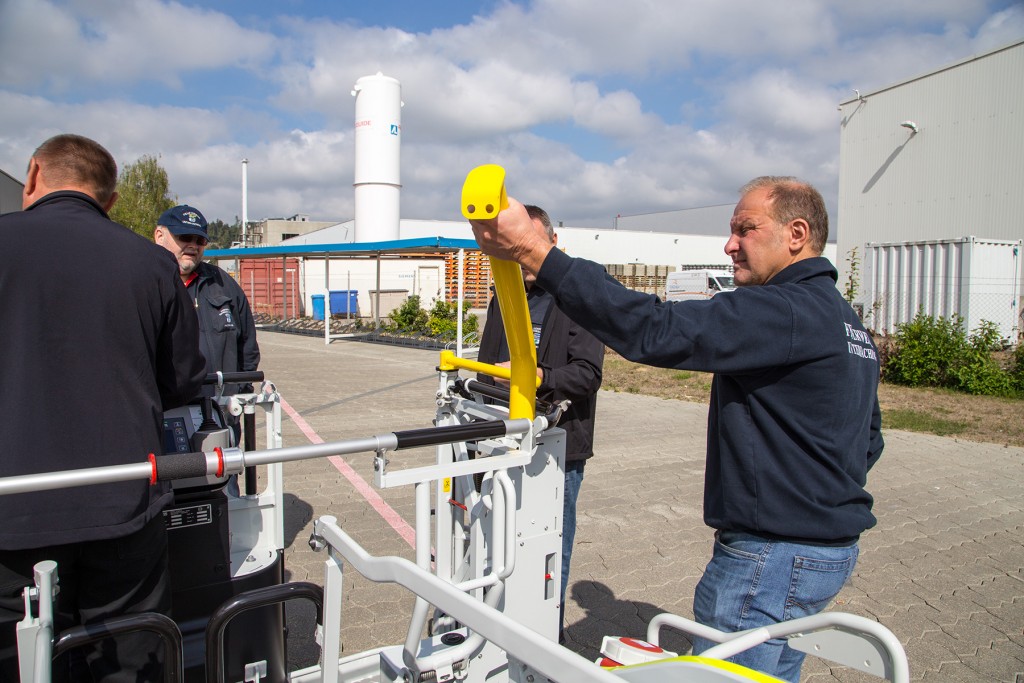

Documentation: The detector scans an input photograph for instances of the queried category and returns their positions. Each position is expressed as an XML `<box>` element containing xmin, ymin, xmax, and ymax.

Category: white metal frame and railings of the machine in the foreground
<box><xmin>0</xmin><ymin>364</ymin><xmax>909</xmax><ymax>683</ymax></box>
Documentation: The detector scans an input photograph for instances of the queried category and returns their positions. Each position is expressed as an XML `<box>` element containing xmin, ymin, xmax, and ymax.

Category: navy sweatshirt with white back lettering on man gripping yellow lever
<box><xmin>537</xmin><ymin>249</ymin><xmax>883</xmax><ymax>545</ymax></box>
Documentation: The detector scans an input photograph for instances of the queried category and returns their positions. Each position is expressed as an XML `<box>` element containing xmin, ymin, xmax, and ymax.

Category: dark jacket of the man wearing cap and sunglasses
<box><xmin>188</xmin><ymin>263</ymin><xmax>259</xmax><ymax>395</ymax></box>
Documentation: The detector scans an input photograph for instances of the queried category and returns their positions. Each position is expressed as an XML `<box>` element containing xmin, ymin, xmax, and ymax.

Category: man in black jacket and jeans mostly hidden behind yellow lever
<box><xmin>477</xmin><ymin>206</ymin><xmax>604</xmax><ymax>640</ymax></box>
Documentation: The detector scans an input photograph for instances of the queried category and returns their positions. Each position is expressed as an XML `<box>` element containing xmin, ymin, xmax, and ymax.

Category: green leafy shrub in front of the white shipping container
<box><xmin>882</xmin><ymin>313</ymin><xmax>1018</xmax><ymax>396</ymax></box>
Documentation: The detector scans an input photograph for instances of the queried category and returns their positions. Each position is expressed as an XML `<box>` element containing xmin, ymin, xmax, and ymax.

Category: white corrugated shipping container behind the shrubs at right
<box><xmin>857</xmin><ymin>237</ymin><xmax>1022</xmax><ymax>343</ymax></box>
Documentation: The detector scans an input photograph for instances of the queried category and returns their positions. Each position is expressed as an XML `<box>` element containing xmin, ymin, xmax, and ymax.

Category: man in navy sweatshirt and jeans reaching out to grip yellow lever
<box><xmin>471</xmin><ymin>176</ymin><xmax>883</xmax><ymax>682</ymax></box>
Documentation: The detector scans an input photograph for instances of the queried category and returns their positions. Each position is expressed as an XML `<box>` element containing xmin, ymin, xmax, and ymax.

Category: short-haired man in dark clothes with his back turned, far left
<box><xmin>0</xmin><ymin>135</ymin><xmax>205</xmax><ymax>681</ymax></box>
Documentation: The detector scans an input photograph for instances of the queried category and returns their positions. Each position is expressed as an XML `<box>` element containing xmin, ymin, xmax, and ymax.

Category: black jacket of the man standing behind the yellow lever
<box><xmin>477</xmin><ymin>288</ymin><xmax>604</xmax><ymax>462</ymax></box>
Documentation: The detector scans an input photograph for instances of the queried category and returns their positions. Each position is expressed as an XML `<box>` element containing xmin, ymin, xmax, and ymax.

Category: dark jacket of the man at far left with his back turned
<box><xmin>0</xmin><ymin>191</ymin><xmax>204</xmax><ymax>550</ymax></box>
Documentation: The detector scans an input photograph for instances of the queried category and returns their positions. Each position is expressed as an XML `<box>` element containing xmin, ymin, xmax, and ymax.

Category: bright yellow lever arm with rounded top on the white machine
<box><xmin>440</xmin><ymin>164</ymin><xmax>540</xmax><ymax>420</ymax></box>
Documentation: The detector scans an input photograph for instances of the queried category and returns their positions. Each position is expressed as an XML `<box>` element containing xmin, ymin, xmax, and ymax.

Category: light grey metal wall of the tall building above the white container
<box><xmin>838</xmin><ymin>41</ymin><xmax>1024</xmax><ymax>307</ymax></box>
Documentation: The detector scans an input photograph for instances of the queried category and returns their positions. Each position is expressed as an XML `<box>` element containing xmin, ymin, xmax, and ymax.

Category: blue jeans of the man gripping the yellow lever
<box><xmin>692</xmin><ymin>531</ymin><xmax>859</xmax><ymax>683</ymax></box>
